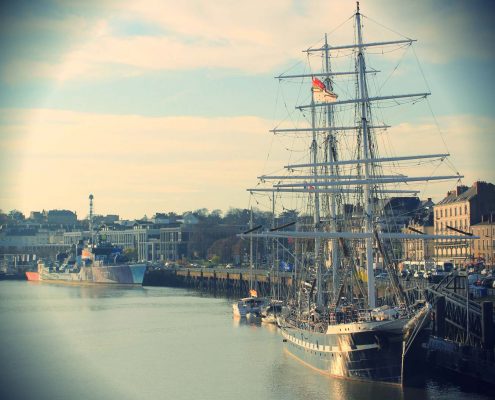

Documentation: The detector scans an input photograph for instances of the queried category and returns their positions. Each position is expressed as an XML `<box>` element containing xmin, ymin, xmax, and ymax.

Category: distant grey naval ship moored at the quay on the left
<box><xmin>26</xmin><ymin>243</ymin><xmax>146</xmax><ymax>285</ymax></box>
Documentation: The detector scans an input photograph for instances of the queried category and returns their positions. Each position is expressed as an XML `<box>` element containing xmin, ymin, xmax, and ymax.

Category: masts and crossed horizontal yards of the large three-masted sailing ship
<box><xmin>244</xmin><ymin>2</ymin><xmax>474</xmax><ymax>310</ymax></box>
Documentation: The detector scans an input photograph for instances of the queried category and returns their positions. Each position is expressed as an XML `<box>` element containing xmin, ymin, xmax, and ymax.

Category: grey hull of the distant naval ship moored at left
<box><xmin>37</xmin><ymin>264</ymin><xmax>146</xmax><ymax>285</ymax></box>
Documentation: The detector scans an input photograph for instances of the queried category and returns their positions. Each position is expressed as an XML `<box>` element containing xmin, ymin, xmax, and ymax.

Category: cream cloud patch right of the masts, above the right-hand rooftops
<box><xmin>379</xmin><ymin>115</ymin><xmax>495</xmax><ymax>200</ymax></box>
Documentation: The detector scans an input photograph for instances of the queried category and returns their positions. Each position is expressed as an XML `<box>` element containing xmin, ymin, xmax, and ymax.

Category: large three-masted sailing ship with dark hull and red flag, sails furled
<box><xmin>241</xmin><ymin>2</ymin><xmax>472</xmax><ymax>385</ymax></box>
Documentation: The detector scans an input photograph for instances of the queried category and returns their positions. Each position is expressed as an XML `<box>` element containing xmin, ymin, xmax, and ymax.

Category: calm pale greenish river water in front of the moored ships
<box><xmin>0</xmin><ymin>281</ymin><xmax>492</xmax><ymax>400</ymax></box>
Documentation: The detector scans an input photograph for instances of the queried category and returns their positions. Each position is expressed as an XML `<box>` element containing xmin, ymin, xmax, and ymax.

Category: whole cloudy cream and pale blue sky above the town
<box><xmin>0</xmin><ymin>0</ymin><xmax>495</xmax><ymax>218</ymax></box>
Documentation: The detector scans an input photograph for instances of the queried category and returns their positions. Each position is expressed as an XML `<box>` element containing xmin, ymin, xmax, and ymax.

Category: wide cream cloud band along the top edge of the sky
<box><xmin>3</xmin><ymin>0</ymin><xmax>494</xmax><ymax>81</ymax></box>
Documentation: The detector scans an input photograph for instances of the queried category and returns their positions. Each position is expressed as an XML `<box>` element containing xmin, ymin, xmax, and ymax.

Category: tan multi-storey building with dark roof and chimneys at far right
<box><xmin>434</xmin><ymin>182</ymin><xmax>495</xmax><ymax>263</ymax></box>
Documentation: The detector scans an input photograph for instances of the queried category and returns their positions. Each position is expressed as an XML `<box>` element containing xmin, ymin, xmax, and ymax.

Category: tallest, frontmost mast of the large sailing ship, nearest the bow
<box><xmin>356</xmin><ymin>2</ymin><xmax>376</xmax><ymax>308</ymax></box>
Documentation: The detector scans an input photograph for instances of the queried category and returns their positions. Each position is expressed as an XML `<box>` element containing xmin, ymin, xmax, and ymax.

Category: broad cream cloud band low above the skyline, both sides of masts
<box><xmin>0</xmin><ymin>109</ymin><xmax>495</xmax><ymax>217</ymax></box>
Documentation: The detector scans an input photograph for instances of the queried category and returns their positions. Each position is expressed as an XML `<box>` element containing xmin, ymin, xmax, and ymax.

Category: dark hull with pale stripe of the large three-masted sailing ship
<box><xmin>281</xmin><ymin>320</ymin><xmax>405</xmax><ymax>385</ymax></box>
